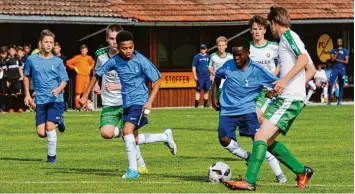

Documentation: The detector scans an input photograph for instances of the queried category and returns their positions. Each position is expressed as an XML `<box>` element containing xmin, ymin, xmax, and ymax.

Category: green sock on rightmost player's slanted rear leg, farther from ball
<box><xmin>268</xmin><ymin>141</ymin><xmax>304</xmax><ymax>175</ymax></box>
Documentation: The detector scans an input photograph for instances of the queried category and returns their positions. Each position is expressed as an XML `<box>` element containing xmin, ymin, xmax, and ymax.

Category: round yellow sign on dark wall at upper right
<box><xmin>317</xmin><ymin>34</ymin><xmax>333</xmax><ymax>63</ymax></box>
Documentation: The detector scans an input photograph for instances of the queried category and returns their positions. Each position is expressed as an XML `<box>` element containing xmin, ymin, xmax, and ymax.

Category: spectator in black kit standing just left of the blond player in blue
<box><xmin>6</xmin><ymin>45</ymin><xmax>24</xmax><ymax>113</ymax></box>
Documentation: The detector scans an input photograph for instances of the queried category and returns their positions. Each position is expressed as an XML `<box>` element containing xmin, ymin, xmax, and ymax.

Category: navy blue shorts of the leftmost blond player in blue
<box><xmin>36</xmin><ymin>102</ymin><xmax>65</xmax><ymax>126</ymax></box>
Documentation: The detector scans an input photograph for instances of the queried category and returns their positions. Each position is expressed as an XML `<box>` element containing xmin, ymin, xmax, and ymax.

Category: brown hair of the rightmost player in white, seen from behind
<box><xmin>267</xmin><ymin>6</ymin><xmax>291</xmax><ymax>28</ymax></box>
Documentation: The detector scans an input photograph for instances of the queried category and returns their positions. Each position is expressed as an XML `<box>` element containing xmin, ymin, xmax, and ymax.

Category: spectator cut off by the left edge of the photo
<box><xmin>0</xmin><ymin>46</ymin><xmax>7</xmax><ymax>113</ymax></box>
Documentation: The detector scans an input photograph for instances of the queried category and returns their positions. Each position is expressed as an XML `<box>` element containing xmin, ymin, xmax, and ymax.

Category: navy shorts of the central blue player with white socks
<box><xmin>123</xmin><ymin>105</ymin><xmax>148</xmax><ymax>130</ymax></box>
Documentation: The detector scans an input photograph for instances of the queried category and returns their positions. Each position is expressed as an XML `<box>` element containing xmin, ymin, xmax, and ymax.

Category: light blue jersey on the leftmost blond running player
<box><xmin>24</xmin><ymin>54</ymin><xmax>69</xmax><ymax>104</ymax></box>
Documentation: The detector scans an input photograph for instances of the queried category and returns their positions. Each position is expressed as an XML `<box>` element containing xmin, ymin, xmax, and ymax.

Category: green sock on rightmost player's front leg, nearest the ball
<box><xmin>245</xmin><ymin>140</ymin><xmax>267</xmax><ymax>184</ymax></box>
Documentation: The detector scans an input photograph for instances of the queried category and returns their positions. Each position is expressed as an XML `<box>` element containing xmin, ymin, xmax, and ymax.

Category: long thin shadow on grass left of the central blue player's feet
<box><xmin>46</xmin><ymin>168</ymin><xmax>125</xmax><ymax>177</ymax></box>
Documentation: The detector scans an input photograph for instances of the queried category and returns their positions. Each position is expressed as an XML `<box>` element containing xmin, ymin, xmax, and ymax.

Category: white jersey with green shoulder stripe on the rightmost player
<box><xmin>278</xmin><ymin>30</ymin><xmax>311</xmax><ymax>101</ymax></box>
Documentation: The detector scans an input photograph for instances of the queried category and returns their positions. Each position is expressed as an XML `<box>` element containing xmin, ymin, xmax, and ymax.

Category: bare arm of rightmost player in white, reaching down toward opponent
<box><xmin>274</xmin><ymin>53</ymin><xmax>309</xmax><ymax>94</ymax></box>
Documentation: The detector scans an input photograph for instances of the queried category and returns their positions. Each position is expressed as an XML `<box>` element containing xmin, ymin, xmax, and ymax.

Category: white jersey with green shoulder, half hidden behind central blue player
<box><xmin>95</xmin><ymin>47</ymin><xmax>122</xmax><ymax>106</ymax></box>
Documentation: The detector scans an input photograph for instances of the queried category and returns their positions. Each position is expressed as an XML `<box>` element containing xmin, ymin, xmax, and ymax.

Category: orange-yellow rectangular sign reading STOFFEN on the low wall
<box><xmin>153</xmin><ymin>72</ymin><xmax>196</xmax><ymax>88</ymax></box>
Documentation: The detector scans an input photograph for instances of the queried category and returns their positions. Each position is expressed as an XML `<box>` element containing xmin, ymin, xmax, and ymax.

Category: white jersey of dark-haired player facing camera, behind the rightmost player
<box><xmin>249</xmin><ymin>40</ymin><xmax>279</xmax><ymax>73</ymax></box>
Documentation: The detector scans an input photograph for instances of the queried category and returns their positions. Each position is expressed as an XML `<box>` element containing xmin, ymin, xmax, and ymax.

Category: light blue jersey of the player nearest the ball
<box><xmin>216</xmin><ymin>59</ymin><xmax>278</xmax><ymax>116</ymax></box>
